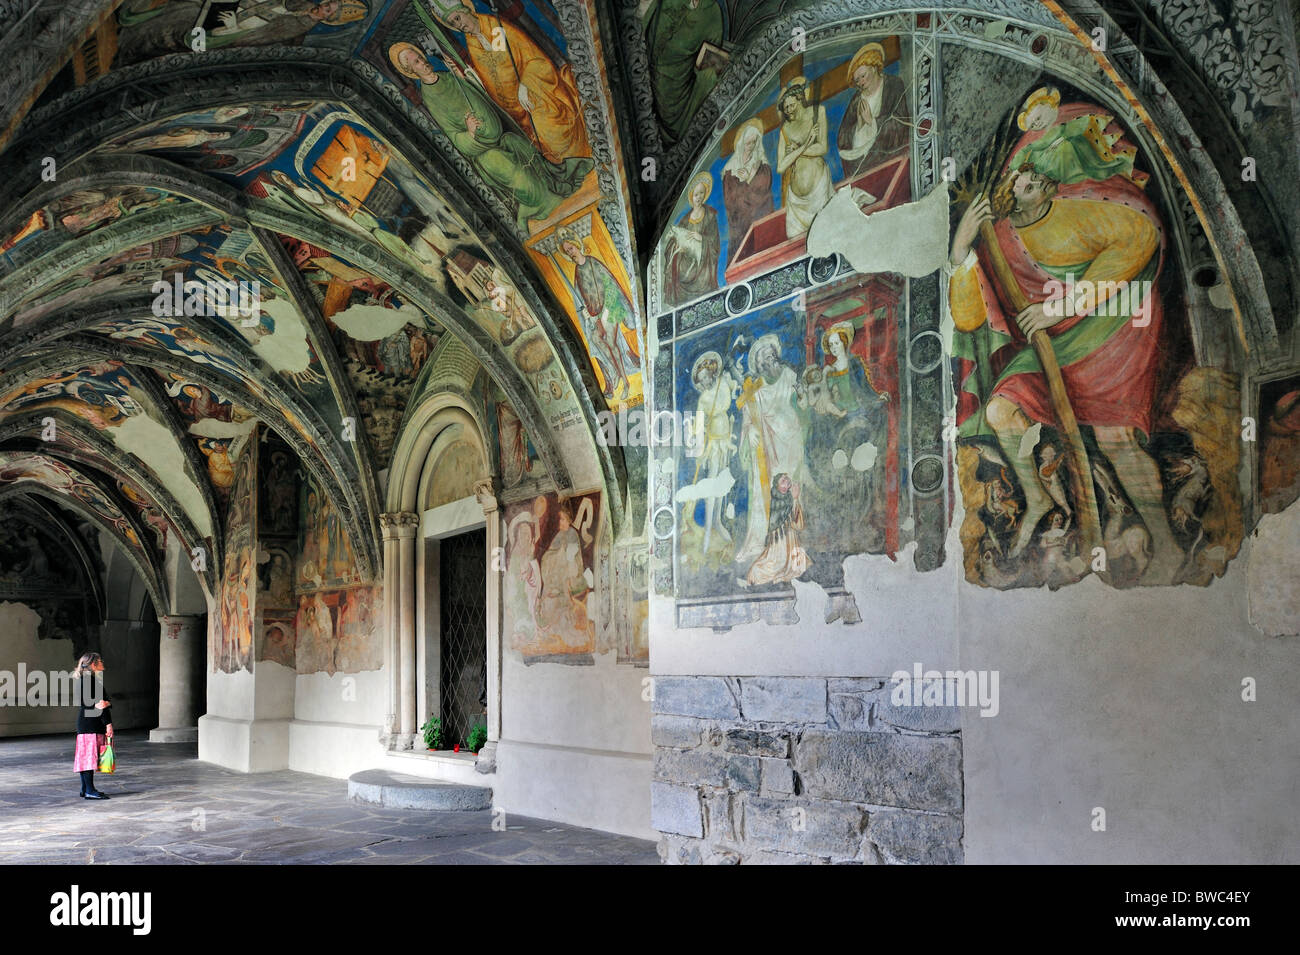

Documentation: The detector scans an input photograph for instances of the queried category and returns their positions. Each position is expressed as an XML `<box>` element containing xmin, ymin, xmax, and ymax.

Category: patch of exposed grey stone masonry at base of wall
<box><xmin>650</xmin><ymin>676</ymin><xmax>963</xmax><ymax>865</ymax></box>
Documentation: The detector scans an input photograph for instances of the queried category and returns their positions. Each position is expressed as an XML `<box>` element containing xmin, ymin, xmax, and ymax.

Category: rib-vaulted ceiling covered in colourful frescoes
<box><xmin>0</xmin><ymin>0</ymin><xmax>1297</xmax><ymax>613</ymax></box>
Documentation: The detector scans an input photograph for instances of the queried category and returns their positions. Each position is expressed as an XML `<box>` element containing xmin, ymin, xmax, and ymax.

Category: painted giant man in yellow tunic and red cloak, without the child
<box><xmin>949</xmin><ymin>155</ymin><xmax>1183</xmax><ymax>583</ymax></box>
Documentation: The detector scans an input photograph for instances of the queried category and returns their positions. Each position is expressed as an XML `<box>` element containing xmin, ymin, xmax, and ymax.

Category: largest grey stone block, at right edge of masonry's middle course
<box><xmin>794</xmin><ymin>730</ymin><xmax>962</xmax><ymax>812</ymax></box>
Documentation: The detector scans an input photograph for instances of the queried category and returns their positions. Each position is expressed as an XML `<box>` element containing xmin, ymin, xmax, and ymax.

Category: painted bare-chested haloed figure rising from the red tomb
<box><xmin>776</xmin><ymin>77</ymin><xmax>833</xmax><ymax>239</ymax></box>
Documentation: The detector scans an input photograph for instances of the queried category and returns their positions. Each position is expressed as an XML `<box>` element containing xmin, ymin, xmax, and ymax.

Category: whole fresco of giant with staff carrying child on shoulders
<box><xmin>948</xmin><ymin>84</ymin><xmax>1242</xmax><ymax>587</ymax></box>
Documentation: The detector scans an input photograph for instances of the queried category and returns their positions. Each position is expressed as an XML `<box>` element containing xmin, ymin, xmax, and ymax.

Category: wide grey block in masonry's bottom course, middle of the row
<box><xmin>742</xmin><ymin>796</ymin><xmax>867</xmax><ymax>859</ymax></box>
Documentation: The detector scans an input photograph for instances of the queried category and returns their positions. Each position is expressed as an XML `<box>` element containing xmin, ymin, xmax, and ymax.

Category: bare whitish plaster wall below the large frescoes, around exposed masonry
<box><xmin>650</xmin><ymin>507</ymin><xmax>1300</xmax><ymax>864</ymax></box>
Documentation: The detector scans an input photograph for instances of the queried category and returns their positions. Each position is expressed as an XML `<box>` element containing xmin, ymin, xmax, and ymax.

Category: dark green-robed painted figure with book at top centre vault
<box><xmin>645</xmin><ymin>0</ymin><xmax>723</xmax><ymax>142</ymax></box>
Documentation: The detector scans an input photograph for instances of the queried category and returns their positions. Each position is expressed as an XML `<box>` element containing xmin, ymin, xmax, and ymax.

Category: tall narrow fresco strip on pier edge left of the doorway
<box><xmin>212</xmin><ymin>442</ymin><xmax>257</xmax><ymax>673</ymax></box>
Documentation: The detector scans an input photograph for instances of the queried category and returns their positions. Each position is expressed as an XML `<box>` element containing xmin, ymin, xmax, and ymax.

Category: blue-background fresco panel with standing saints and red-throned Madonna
<box><xmin>673</xmin><ymin>275</ymin><xmax>902</xmax><ymax>595</ymax></box>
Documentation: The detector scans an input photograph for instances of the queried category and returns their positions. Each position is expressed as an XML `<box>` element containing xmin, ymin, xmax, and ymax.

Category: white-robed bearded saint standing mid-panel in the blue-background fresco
<box><xmin>736</xmin><ymin>334</ymin><xmax>811</xmax><ymax>585</ymax></box>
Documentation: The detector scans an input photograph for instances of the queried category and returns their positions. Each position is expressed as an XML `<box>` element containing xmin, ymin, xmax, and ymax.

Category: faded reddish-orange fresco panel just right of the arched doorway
<box><xmin>503</xmin><ymin>494</ymin><xmax>602</xmax><ymax>664</ymax></box>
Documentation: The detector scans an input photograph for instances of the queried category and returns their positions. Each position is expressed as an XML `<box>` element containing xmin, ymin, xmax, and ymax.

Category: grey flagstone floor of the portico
<box><xmin>0</xmin><ymin>733</ymin><xmax>659</xmax><ymax>865</ymax></box>
